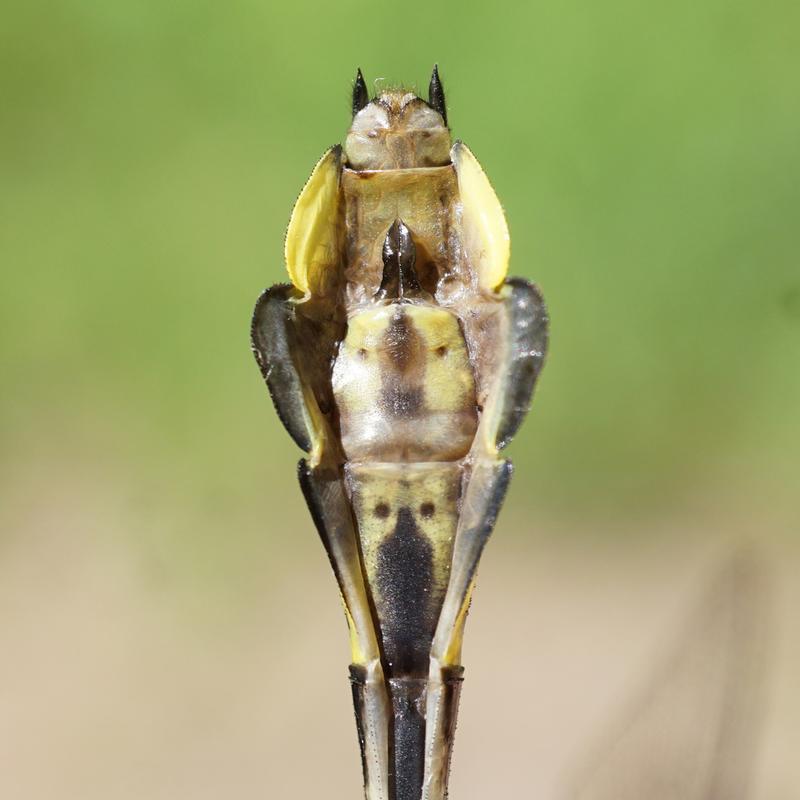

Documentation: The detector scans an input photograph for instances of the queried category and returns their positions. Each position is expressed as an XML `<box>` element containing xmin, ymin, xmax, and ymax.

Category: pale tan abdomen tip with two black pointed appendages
<box><xmin>344</xmin><ymin>67</ymin><xmax>452</xmax><ymax>170</ymax></box>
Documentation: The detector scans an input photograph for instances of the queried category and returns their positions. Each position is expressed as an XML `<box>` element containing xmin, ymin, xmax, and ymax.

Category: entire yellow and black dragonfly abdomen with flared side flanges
<box><xmin>251</xmin><ymin>67</ymin><xmax>548</xmax><ymax>800</ymax></box>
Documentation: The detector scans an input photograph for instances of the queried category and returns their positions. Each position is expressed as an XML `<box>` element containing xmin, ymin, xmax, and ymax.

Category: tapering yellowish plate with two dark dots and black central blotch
<box><xmin>345</xmin><ymin>462</ymin><xmax>462</xmax><ymax>677</ymax></box>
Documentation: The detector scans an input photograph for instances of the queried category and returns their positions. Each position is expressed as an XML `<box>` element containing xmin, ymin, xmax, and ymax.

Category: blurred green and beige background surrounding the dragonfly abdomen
<box><xmin>0</xmin><ymin>0</ymin><xmax>800</xmax><ymax>800</ymax></box>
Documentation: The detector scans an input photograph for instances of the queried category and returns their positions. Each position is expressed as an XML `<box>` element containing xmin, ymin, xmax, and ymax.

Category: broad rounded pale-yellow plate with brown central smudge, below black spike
<box><xmin>332</xmin><ymin>303</ymin><xmax>478</xmax><ymax>462</ymax></box>
